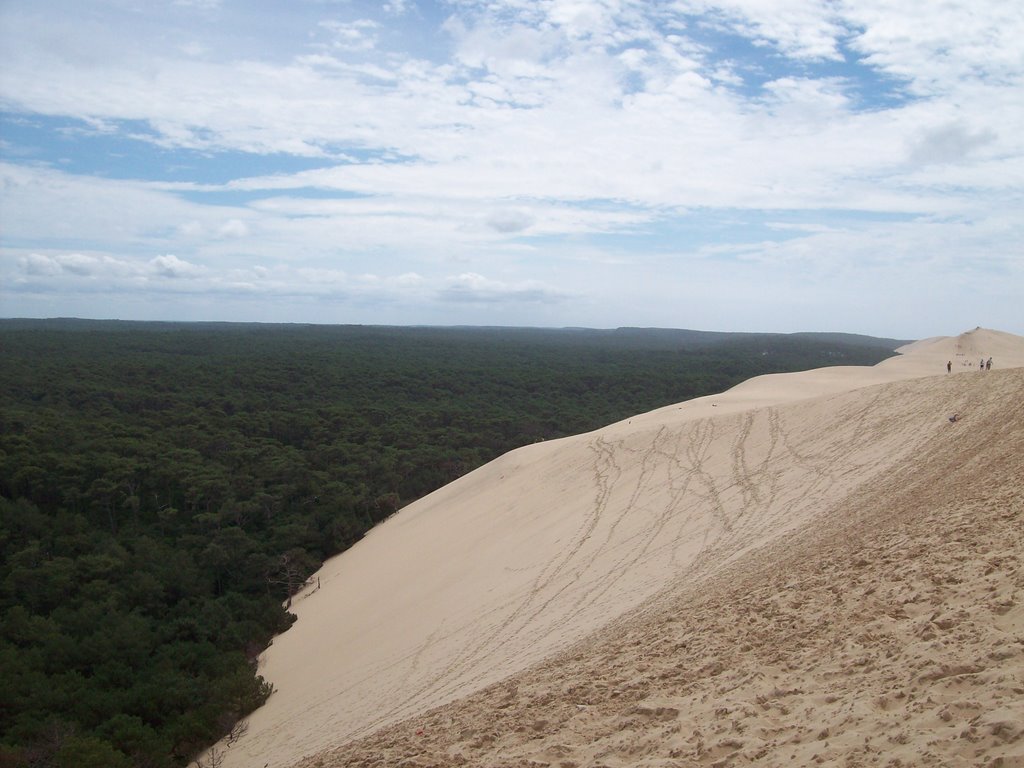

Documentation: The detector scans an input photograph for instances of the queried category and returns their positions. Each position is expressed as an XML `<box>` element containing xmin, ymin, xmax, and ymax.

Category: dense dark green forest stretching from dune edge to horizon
<box><xmin>0</xmin><ymin>319</ymin><xmax>902</xmax><ymax>768</ymax></box>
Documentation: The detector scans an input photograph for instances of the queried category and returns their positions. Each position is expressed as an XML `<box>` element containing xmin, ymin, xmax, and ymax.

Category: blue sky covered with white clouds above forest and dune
<box><xmin>0</xmin><ymin>0</ymin><xmax>1024</xmax><ymax>338</ymax></box>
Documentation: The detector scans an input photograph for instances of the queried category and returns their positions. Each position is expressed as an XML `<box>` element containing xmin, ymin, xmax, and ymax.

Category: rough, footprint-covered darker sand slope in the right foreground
<box><xmin>300</xmin><ymin>371</ymin><xmax>1024</xmax><ymax>768</ymax></box>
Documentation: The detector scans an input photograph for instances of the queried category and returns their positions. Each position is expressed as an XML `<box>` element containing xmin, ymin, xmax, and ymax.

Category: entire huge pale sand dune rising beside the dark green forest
<box><xmin>209</xmin><ymin>329</ymin><xmax>1024</xmax><ymax>768</ymax></box>
